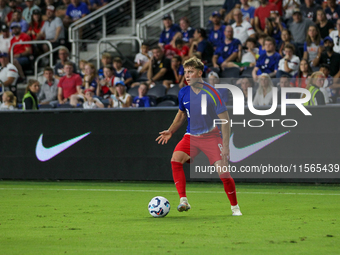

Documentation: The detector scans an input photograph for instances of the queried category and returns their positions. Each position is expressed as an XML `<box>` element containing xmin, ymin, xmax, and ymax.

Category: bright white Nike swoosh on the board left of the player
<box><xmin>35</xmin><ymin>132</ymin><xmax>91</xmax><ymax>161</ymax></box>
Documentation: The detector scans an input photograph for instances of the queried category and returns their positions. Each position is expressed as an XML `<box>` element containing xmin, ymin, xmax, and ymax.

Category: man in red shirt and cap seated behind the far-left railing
<box><xmin>10</xmin><ymin>22</ymin><xmax>32</xmax><ymax>67</ymax></box>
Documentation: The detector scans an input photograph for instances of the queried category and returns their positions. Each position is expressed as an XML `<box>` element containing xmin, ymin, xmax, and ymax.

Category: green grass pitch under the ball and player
<box><xmin>0</xmin><ymin>181</ymin><xmax>340</xmax><ymax>255</ymax></box>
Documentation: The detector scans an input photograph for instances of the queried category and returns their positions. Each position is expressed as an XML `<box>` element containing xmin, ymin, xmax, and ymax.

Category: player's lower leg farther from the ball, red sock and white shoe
<box><xmin>214</xmin><ymin>160</ymin><xmax>242</xmax><ymax>216</ymax></box>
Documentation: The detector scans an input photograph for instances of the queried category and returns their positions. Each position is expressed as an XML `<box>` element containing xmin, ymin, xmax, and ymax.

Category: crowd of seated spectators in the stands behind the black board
<box><xmin>0</xmin><ymin>0</ymin><xmax>340</xmax><ymax>109</ymax></box>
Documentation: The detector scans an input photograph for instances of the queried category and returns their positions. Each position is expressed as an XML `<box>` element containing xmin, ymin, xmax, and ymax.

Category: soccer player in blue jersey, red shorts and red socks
<box><xmin>156</xmin><ymin>57</ymin><xmax>242</xmax><ymax>216</ymax></box>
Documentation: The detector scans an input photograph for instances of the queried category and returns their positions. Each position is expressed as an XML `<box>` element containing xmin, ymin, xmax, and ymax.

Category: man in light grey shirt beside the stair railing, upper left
<box><xmin>38</xmin><ymin>5</ymin><xmax>65</xmax><ymax>52</ymax></box>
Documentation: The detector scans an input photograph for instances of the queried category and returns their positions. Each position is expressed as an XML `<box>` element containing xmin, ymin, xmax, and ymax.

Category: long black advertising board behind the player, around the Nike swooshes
<box><xmin>0</xmin><ymin>106</ymin><xmax>340</xmax><ymax>182</ymax></box>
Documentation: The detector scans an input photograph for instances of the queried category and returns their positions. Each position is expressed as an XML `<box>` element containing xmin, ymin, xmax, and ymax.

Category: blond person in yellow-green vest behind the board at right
<box><xmin>304</xmin><ymin>72</ymin><xmax>325</xmax><ymax>106</ymax></box>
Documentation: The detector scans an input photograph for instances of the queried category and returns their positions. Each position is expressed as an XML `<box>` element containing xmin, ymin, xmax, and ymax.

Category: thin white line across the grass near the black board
<box><xmin>0</xmin><ymin>188</ymin><xmax>340</xmax><ymax>196</ymax></box>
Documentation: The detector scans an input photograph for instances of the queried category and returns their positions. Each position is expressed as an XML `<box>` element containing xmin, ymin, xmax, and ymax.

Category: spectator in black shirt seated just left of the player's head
<box><xmin>148</xmin><ymin>47</ymin><xmax>173</xmax><ymax>88</ymax></box>
